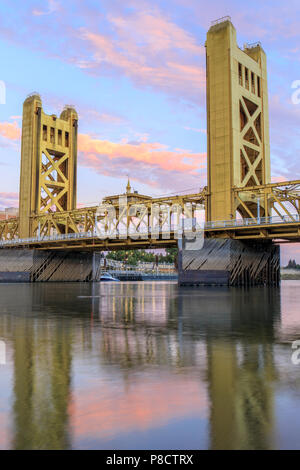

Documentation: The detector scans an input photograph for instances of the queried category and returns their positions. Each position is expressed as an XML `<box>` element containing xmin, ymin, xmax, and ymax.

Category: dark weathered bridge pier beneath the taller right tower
<box><xmin>178</xmin><ymin>238</ymin><xmax>280</xmax><ymax>286</ymax></box>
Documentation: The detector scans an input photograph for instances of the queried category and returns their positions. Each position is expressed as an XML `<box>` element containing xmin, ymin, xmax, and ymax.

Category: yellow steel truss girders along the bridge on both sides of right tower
<box><xmin>0</xmin><ymin>180</ymin><xmax>300</xmax><ymax>249</ymax></box>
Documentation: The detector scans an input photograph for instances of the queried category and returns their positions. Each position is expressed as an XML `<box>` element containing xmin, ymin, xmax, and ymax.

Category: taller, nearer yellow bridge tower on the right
<box><xmin>206</xmin><ymin>17</ymin><xmax>270</xmax><ymax>221</ymax></box>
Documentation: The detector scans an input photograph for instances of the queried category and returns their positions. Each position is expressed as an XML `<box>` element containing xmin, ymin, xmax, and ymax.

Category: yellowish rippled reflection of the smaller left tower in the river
<box><xmin>2</xmin><ymin>285</ymin><xmax>72</xmax><ymax>449</ymax></box>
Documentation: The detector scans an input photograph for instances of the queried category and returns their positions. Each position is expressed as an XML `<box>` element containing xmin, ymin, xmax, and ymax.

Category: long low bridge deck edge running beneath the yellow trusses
<box><xmin>0</xmin><ymin>214</ymin><xmax>300</xmax><ymax>250</ymax></box>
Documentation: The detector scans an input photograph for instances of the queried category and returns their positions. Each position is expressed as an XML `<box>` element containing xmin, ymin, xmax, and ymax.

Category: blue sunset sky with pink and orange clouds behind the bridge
<box><xmin>0</xmin><ymin>0</ymin><xmax>300</xmax><ymax>262</ymax></box>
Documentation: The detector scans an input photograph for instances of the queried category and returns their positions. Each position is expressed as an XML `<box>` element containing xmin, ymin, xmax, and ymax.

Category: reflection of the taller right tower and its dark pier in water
<box><xmin>177</xmin><ymin>288</ymin><xmax>280</xmax><ymax>449</ymax></box>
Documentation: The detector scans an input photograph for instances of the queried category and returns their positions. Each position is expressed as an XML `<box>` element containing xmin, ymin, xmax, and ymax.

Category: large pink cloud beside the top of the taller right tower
<box><xmin>75</xmin><ymin>11</ymin><xmax>206</xmax><ymax>101</ymax></box>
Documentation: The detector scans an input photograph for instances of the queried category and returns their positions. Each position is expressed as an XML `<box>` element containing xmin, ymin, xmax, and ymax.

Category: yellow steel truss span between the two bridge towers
<box><xmin>0</xmin><ymin>188</ymin><xmax>207</xmax><ymax>244</ymax></box>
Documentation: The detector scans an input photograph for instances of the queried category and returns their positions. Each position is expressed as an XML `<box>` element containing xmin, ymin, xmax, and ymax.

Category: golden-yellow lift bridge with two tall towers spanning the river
<box><xmin>0</xmin><ymin>17</ymin><xmax>300</xmax><ymax>285</ymax></box>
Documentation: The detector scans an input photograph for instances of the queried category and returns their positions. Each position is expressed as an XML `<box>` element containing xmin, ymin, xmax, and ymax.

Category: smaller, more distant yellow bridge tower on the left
<box><xmin>19</xmin><ymin>94</ymin><xmax>78</xmax><ymax>238</ymax></box>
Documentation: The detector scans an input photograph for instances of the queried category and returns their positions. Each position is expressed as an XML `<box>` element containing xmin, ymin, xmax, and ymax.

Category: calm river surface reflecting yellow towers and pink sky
<box><xmin>0</xmin><ymin>281</ymin><xmax>300</xmax><ymax>449</ymax></box>
